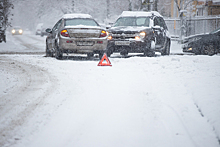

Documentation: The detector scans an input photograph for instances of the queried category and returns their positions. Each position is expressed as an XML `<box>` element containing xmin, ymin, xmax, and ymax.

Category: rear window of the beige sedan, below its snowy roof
<box><xmin>65</xmin><ymin>18</ymin><xmax>98</xmax><ymax>26</ymax></box>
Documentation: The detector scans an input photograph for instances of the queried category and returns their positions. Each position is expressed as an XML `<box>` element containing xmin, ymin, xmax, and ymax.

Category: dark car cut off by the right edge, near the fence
<box><xmin>182</xmin><ymin>28</ymin><xmax>220</xmax><ymax>56</ymax></box>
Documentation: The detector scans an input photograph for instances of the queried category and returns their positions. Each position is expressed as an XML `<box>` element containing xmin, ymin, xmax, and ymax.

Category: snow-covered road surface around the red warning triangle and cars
<box><xmin>0</xmin><ymin>34</ymin><xmax>220</xmax><ymax>147</ymax></box>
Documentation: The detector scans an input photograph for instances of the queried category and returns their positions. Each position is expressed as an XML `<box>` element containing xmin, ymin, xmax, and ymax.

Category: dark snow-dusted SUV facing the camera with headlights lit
<box><xmin>107</xmin><ymin>11</ymin><xmax>170</xmax><ymax>57</ymax></box>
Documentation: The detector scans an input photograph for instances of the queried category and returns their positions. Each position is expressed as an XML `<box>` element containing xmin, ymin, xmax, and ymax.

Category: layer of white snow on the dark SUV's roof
<box><xmin>120</xmin><ymin>11</ymin><xmax>162</xmax><ymax>17</ymax></box>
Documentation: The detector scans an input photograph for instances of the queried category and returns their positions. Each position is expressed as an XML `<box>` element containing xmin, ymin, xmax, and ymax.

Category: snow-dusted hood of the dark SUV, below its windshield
<box><xmin>109</xmin><ymin>26</ymin><xmax>150</xmax><ymax>33</ymax></box>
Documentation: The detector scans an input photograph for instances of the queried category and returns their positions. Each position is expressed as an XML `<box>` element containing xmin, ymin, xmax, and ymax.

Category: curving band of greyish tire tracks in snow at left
<box><xmin>0</xmin><ymin>56</ymin><xmax>57</xmax><ymax>147</ymax></box>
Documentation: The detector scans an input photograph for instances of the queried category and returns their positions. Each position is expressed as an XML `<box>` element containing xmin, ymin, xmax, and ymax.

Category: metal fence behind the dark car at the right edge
<box><xmin>165</xmin><ymin>16</ymin><xmax>220</xmax><ymax>38</ymax></box>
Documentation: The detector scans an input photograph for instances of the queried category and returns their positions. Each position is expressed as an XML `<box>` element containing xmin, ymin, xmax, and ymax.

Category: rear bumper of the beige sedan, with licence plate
<box><xmin>59</xmin><ymin>37</ymin><xmax>108</xmax><ymax>53</ymax></box>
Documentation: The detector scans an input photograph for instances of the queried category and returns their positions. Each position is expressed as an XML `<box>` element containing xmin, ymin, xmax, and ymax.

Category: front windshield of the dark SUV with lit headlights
<box><xmin>114</xmin><ymin>17</ymin><xmax>150</xmax><ymax>27</ymax></box>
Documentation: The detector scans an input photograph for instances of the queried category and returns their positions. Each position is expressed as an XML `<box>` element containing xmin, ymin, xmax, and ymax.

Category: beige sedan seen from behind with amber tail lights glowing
<box><xmin>46</xmin><ymin>14</ymin><xmax>107</xmax><ymax>59</ymax></box>
